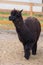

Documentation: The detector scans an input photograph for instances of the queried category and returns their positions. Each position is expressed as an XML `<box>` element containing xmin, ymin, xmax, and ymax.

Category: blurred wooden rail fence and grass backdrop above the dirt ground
<box><xmin>0</xmin><ymin>0</ymin><xmax>43</xmax><ymax>30</ymax></box>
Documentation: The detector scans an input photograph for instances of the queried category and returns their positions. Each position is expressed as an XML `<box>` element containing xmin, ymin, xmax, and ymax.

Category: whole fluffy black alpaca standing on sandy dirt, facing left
<box><xmin>9</xmin><ymin>9</ymin><xmax>41</xmax><ymax>59</ymax></box>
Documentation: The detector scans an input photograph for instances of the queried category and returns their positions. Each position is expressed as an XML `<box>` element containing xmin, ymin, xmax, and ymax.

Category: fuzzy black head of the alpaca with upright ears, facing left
<box><xmin>9</xmin><ymin>9</ymin><xmax>23</xmax><ymax>23</ymax></box>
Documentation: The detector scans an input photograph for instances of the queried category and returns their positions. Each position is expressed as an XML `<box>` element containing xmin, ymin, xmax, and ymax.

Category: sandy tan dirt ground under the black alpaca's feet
<box><xmin>0</xmin><ymin>30</ymin><xmax>43</xmax><ymax>65</ymax></box>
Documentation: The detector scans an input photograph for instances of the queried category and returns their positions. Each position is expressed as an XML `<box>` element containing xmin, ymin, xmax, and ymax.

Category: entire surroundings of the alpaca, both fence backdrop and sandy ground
<box><xmin>0</xmin><ymin>0</ymin><xmax>43</xmax><ymax>65</ymax></box>
